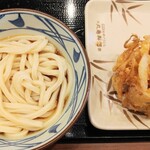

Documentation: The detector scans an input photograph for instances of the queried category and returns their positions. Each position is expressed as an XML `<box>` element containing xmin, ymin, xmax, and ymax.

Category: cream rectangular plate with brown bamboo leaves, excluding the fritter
<box><xmin>85</xmin><ymin>0</ymin><xmax>150</xmax><ymax>130</ymax></box>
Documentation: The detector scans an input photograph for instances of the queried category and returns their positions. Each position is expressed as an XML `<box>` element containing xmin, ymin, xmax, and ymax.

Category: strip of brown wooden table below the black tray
<box><xmin>49</xmin><ymin>142</ymin><xmax>150</xmax><ymax>150</ymax></box>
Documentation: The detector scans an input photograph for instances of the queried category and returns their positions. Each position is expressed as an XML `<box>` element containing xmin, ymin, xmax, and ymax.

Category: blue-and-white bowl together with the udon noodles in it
<box><xmin>0</xmin><ymin>8</ymin><xmax>90</xmax><ymax>150</ymax></box>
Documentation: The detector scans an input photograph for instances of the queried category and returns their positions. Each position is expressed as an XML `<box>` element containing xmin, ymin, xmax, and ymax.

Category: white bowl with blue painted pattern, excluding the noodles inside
<box><xmin>0</xmin><ymin>9</ymin><xmax>90</xmax><ymax>150</ymax></box>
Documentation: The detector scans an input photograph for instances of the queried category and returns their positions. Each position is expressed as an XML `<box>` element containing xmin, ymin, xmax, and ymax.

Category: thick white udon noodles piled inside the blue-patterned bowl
<box><xmin>0</xmin><ymin>35</ymin><xmax>73</xmax><ymax>139</ymax></box>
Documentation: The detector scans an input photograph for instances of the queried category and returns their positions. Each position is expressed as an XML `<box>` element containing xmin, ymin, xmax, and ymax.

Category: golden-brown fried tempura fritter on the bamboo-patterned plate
<box><xmin>112</xmin><ymin>35</ymin><xmax>150</xmax><ymax>117</ymax></box>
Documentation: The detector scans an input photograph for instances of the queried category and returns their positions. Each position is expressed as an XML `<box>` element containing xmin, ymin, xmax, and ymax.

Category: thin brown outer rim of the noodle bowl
<box><xmin>0</xmin><ymin>8</ymin><xmax>91</xmax><ymax>149</ymax></box>
